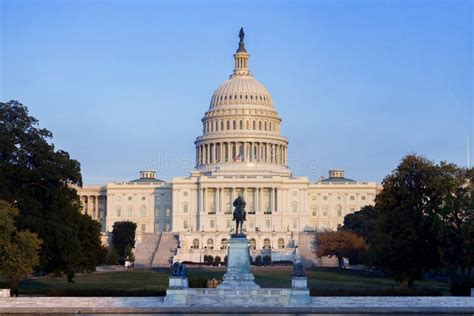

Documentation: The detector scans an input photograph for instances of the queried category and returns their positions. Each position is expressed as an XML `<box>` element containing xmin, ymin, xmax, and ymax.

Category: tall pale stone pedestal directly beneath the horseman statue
<box><xmin>217</xmin><ymin>235</ymin><xmax>260</xmax><ymax>289</ymax></box>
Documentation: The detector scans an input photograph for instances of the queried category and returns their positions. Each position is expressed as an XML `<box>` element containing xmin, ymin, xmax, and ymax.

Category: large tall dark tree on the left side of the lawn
<box><xmin>0</xmin><ymin>101</ymin><xmax>100</xmax><ymax>273</ymax></box>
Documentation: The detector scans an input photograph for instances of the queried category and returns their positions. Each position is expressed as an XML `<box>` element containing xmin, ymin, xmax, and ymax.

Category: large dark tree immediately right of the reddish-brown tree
<box><xmin>371</xmin><ymin>155</ymin><xmax>443</xmax><ymax>287</ymax></box>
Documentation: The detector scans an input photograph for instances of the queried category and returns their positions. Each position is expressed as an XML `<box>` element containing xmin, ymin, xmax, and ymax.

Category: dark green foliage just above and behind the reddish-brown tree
<box><xmin>342</xmin><ymin>205</ymin><xmax>379</xmax><ymax>244</ymax></box>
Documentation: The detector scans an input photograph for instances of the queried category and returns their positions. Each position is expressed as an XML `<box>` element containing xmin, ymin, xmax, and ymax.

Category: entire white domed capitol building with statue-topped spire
<box><xmin>78</xmin><ymin>31</ymin><xmax>380</xmax><ymax>267</ymax></box>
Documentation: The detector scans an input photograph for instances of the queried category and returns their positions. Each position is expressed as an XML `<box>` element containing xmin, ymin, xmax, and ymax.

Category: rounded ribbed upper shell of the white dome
<box><xmin>210</xmin><ymin>75</ymin><xmax>272</xmax><ymax>108</ymax></box>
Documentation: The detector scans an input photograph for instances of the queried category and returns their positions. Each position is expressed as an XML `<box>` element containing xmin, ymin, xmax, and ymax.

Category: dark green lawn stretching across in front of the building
<box><xmin>0</xmin><ymin>267</ymin><xmax>450</xmax><ymax>296</ymax></box>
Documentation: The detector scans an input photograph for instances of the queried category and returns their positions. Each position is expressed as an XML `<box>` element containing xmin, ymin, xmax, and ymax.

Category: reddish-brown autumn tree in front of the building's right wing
<box><xmin>316</xmin><ymin>231</ymin><xmax>368</xmax><ymax>262</ymax></box>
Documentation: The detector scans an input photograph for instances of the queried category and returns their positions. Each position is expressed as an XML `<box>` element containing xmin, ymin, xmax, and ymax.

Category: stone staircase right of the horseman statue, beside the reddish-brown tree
<box><xmin>298</xmin><ymin>232</ymin><xmax>338</xmax><ymax>267</ymax></box>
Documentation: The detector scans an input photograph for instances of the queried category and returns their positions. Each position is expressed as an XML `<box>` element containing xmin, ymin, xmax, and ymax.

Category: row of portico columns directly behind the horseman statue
<box><xmin>198</xmin><ymin>187</ymin><xmax>278</xmax><ymax>214</ymax></box>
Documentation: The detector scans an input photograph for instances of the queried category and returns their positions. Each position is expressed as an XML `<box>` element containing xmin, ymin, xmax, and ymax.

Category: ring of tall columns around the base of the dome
<box><xmin>196</xmin><ymin>142</ymin><xmax>287</xmax><ymax>166</ymax></box>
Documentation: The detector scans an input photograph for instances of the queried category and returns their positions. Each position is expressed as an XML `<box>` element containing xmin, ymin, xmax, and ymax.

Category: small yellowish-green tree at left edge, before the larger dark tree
<box><xmin>0</xmin><ymin>200</ymin><xmax>42</xmax><ymax>296</ymax></box>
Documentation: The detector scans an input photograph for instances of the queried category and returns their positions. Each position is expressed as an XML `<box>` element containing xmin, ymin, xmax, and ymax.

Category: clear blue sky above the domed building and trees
<box><xmin>0</xmin><ymin>0</ymin><xmax>474</xmax><ymax>184</ymax></box>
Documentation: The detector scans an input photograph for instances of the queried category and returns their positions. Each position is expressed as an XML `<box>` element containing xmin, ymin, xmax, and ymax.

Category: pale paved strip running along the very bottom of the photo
<box><xmin>0</xmin><ymin>297</ymin><xmax>474</xmax><ymax>314</ymax></box>
